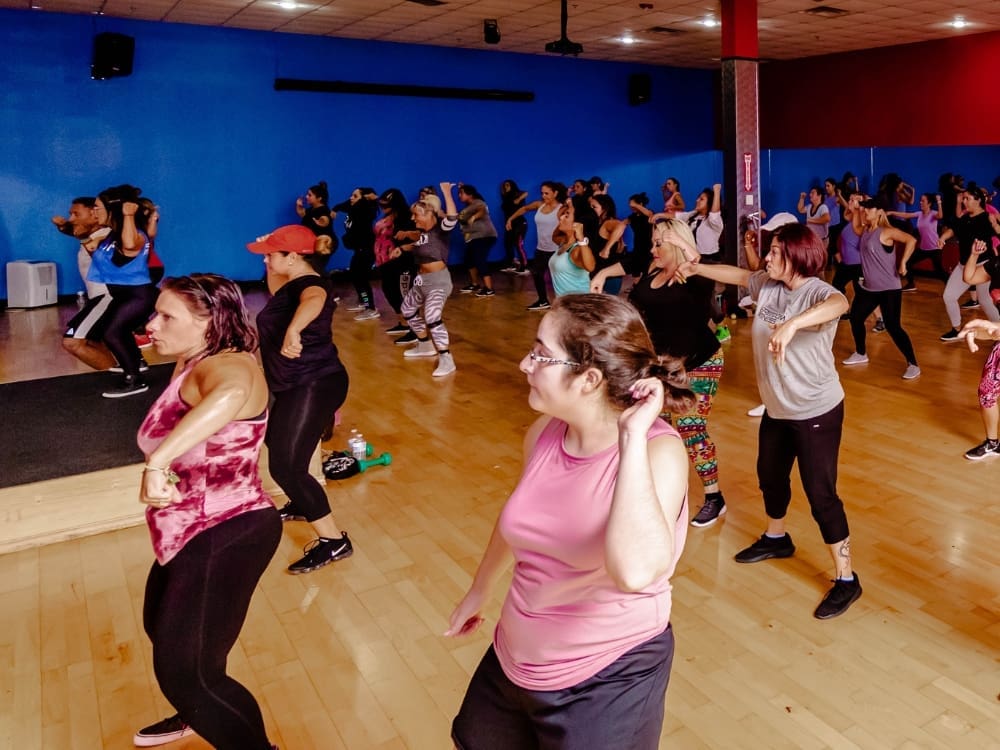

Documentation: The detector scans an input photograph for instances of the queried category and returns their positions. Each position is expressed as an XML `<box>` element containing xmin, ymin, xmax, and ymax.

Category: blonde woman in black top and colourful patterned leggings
<box><xmin>591</xmin><ymin>219</ymin><xmax>726</xmax><ymax>526</ymax></box>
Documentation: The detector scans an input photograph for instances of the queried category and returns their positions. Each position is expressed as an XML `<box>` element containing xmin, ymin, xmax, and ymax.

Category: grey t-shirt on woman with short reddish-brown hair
<box><xmin>747</xmin><ymin>271</ymin><xmax>844</xmax><ymax>420</ymax></box>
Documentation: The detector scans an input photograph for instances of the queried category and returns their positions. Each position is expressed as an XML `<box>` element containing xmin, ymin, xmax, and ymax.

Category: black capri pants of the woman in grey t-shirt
<box><xmin>757</xmin><ymin>401</ymin><xmax>851</xmax><ymax>544</ymax></box>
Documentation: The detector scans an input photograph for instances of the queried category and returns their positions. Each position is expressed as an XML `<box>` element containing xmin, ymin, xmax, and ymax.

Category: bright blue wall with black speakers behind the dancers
<box><xmin>0</xmin><ymin>11</ymin><xmax>721</xmax><ymax>298</ymax></box>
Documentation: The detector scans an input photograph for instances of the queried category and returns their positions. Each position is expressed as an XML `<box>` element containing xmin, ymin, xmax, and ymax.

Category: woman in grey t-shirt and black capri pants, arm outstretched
<box><xmin>678</xmin><ymin>224</ymin><xmax>861</xmax><ymax>620</ymax></box>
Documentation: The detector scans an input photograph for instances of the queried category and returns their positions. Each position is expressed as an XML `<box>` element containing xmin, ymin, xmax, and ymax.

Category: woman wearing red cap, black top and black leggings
<box><xmin>247</xmin><ymin>224</ymin><xmax>354</xmax><ymax>573</ymax></box>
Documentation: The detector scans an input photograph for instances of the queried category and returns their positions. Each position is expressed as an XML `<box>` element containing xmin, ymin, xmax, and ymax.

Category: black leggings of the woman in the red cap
<box><xmin>264</xmin><ymin>371</ymin><xmax>348</xmax><ymax>521</ymax></box>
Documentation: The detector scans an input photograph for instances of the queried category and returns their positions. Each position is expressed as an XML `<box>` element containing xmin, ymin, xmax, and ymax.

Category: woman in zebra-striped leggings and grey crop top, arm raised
<box><xmin>393</xmin><ymin>182</ymin><xmax>458</xmax><ymax>378</ymax></box>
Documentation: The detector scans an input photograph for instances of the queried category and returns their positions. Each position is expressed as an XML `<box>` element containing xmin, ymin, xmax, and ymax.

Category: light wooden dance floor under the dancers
<box><xmin>0</xmin><ymin>275</ymin><xmax>1000</xmax><ymax>750</ymax></box>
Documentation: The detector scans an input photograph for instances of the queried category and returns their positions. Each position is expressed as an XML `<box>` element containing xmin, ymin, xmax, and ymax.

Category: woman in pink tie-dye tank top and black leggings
<box><xmin>134</xmin><ymin>274</ymin><xmax>278</xmax><ymax>750</ymax></box>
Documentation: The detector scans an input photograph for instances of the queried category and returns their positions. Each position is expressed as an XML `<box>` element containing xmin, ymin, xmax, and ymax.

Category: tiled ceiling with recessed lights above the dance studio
<box><xmin>0</xmin><ymin>0</ymin><xmax>1000</xmax><ymax>67</ymax></box>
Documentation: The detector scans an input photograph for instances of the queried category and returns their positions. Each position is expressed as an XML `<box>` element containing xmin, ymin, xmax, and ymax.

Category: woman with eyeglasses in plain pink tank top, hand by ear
<box><xmin>446</xmin><ymin>294</ymin><xmax>691</xmax><ymax>750</ymax></box>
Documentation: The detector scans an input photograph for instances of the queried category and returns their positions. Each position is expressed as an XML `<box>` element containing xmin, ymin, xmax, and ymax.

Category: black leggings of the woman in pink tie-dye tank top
<box><xmin>142</xmin><ymin>508</ymin><xmax>281</xmax><ymax>750</ymax></box>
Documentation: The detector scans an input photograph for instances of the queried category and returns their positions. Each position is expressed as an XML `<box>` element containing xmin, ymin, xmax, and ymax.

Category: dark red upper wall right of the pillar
<box><xmin>760</xmin><ymin>31</ymin><xmax>1000</xmax><ymax>148</ymax></box>
